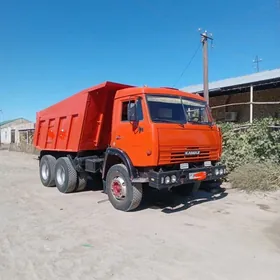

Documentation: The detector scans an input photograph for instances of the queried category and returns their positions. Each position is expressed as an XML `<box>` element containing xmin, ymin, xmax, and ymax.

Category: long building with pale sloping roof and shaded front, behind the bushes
<box><xmin>182</xmin><ymin>69</ymin><xmax>280</xmax><ymax>123</ymax></box>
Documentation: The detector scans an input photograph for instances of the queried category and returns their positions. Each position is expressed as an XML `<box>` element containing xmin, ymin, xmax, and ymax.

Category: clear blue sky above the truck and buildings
<box><xmin>0</xmin><ymin>0</ymin><xmax>280</xmax><ymax>121</ymax></box>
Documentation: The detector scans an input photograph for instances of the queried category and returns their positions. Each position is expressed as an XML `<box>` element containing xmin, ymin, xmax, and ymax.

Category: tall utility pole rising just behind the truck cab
<box><xmin>199</xmin><ymin>29</ymin><xmax>213</xmax><ymax>105</ymax></box>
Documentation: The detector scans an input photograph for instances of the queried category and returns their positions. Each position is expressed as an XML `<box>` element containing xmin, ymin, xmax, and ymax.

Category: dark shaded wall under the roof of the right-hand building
<box><xmin>210</xmin><ymin>88</ymin><xmax>280</xmax><ymax>122</ymax></box>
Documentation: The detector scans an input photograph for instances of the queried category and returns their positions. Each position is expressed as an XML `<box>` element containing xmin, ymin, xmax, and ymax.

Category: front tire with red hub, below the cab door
<box><xmin>106</xmin><ymin>164</ymin><xmax>143</xmax><ymax>212</ymax></box>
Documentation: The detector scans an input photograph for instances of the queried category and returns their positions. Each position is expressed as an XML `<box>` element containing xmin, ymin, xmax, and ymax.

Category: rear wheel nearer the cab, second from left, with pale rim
<box><xmin>55</xmin><ymin>157</ymin><xmax>79</xmax><ymax>193</ymax></box>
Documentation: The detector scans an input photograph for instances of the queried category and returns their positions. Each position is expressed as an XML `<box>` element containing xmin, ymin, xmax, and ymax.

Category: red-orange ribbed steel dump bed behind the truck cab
<box><xmin>34</xmin><ymin>82</ymin><xmax>131</xmax><ymax>152</ymax></box>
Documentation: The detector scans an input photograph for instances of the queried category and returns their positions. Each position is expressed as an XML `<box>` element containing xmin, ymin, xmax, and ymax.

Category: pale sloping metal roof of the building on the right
<box><xmin>181</xmin><ymin>68</ymin><xmax>280</xmax><ymax>93</ymax></box>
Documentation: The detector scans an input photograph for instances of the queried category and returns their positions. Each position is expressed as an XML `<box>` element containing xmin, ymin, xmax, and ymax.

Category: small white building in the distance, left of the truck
<box><xmin>0</xmin><ymin>118</ymin><xmax>34</xmax><ymax>145</ymax></box>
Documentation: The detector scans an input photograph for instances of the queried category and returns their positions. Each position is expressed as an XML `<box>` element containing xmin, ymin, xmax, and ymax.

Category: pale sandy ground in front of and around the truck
<box><xmin>0</xmin><ymin>151</ymin><xmax>280</xmax><ymax>280</ymax></box>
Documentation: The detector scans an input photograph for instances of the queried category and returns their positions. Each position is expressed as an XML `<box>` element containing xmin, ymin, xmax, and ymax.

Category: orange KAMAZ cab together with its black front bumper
<box><xmin>100</xmin><ymin>87</ymin><xmax>226</xmax><ymax>210</ymax></box>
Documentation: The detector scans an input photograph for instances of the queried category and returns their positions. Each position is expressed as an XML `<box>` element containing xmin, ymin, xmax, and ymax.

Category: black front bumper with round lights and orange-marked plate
<box><xmin>148</xmin><ymin>165</ymin><xmax>227</xmax><ymax>190</ymax></box>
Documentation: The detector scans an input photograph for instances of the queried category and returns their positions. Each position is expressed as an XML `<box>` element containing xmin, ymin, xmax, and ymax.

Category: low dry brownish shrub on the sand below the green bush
<box><xmin>229</xmin><ymin>162</ymin><xmax>280</xmax><ymax>192</ymax></box>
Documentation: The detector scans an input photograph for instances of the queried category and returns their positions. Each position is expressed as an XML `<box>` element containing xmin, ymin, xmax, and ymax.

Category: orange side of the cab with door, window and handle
<box><xmin>112</xmin><ymin>97</ymin><xmax>152</xmax><ymax>166</ymax></box>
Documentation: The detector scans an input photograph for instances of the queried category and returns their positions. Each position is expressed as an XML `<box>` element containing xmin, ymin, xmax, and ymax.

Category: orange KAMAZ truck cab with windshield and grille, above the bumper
<box><xmin>111</xmin><ymin>85</ymin><xmax>221</xmax><ymax>167</ymax></box>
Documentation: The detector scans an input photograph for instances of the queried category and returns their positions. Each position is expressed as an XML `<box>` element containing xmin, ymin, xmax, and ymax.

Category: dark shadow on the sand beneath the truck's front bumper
<box><xmin>139</xmin><ymin>187</ymin><xmax>228</xmax><ymax>214</ymax></box>
